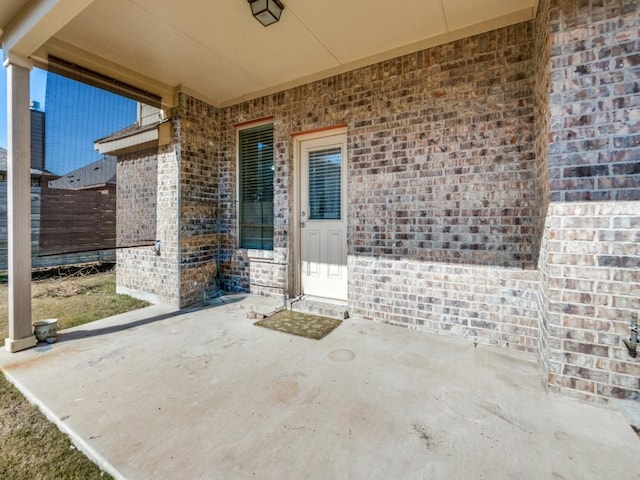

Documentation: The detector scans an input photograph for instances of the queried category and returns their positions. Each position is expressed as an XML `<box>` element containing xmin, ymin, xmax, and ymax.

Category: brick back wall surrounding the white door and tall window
<box><xmin>219</xmin><ymin>22</ymin><xmax>538</xmax><ymax>350</ymax></box>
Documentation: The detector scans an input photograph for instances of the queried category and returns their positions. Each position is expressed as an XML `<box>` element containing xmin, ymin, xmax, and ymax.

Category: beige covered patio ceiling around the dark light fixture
<box><xmin>0</xmin><ymin>0</ymin><xmax>538</xmax><ymax>106</ymax></box>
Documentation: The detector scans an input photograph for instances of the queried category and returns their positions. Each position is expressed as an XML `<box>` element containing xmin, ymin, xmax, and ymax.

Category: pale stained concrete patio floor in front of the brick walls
<box><xmin>0</xmin><ymin>295</ymin><xmax>640</xmax><ymax>480</ymax></box>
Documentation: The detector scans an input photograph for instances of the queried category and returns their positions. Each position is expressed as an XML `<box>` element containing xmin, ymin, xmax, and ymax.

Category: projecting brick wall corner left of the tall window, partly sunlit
<box><xmin>117</xmin><ymin>94</ymin><xmax>219</xmax><ymax>307</ymax></box>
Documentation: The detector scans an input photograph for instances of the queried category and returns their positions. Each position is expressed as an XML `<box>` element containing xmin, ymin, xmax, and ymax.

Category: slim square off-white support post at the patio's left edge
<box><xmin>4</xmin><ymin>55</ymin><xmax>36</xmax><ymax>352</ymax></box>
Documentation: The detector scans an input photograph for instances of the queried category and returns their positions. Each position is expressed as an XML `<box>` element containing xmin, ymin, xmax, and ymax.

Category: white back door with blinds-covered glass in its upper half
<box><xmin>300</xmin><ymin>135</ymin><xmax>347</xmax><ymax>300</ymax></box>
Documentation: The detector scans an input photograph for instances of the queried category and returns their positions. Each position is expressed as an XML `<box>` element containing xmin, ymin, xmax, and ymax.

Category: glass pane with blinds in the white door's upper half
<box><xmin>309</xmin><ymin>147</ymin><xmax>342</xmax><ymax>220</ymax></box>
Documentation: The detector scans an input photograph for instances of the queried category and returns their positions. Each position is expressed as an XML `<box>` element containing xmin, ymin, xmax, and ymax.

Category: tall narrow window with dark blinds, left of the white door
<box><xmin>238</xmin><ymin>124</ymin><xmax>274</xmax><ymax>250</ymax></box>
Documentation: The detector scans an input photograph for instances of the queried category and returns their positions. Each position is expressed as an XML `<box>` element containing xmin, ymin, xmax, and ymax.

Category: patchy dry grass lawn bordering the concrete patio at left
<box><xmin>0</xmin><ymin>273</ymin><xmax>148</xmax><ymax>480</ymax></box>
